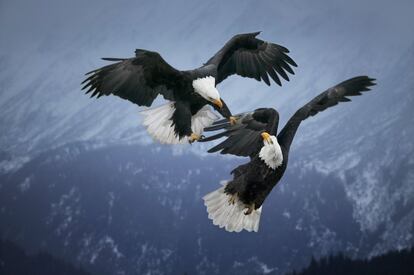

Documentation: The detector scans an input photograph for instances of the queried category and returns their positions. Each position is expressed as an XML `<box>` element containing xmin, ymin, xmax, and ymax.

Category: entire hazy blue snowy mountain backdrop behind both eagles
<box><xmin>0</xmin><ymin>0</ymin><xmax>414</xmax><ymax>274</ymax></box>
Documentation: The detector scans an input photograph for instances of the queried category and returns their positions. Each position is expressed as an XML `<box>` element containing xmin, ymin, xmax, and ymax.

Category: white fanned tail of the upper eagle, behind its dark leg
<box><xmin>140</xmin><ymin>102</ymin><xmax>218</xmax><ymax>144</ymax></box>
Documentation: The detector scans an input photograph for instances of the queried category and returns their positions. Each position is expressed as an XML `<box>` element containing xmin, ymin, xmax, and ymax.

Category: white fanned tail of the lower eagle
<box><xmin>203</xmin><ymin>183</ymin><xmax>262</xmax><ymax>232</ymax></box>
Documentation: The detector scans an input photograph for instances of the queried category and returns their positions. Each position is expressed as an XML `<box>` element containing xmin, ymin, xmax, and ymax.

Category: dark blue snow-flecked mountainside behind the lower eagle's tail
<box><xmin>0</xmin><ymin>139</ymin><xmax>413</xmax><ymax>274</ymax></box>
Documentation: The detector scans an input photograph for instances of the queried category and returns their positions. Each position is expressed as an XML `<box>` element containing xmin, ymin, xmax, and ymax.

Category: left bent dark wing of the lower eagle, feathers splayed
<box><xmin>200</xmin><ymin>108</ymin><xmax>279</xmax><ymax>157</ymax></box>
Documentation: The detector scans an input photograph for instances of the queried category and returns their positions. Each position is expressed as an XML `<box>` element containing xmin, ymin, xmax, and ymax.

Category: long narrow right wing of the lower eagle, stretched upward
<box><xmin>277</xmin><ymin>76</ymin><xmax>375</xmax><ymax>152</ymax></box>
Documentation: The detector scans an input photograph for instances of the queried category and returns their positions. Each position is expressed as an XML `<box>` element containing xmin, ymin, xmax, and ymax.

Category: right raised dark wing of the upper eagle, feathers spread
<box><xmin>206</xmin><ymin>32</ymin><xmax>297</xmax><ymax>85</ymax></box>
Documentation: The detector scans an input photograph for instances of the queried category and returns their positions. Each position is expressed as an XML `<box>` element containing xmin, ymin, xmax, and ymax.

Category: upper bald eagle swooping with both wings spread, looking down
<box><xmin>82</xmin><ymin>32</ymin><xmax>296</xmax><ymax>144</ymax></box>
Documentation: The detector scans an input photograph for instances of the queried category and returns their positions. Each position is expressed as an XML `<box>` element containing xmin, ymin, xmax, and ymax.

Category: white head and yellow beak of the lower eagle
<box><xmin>259</xmin><ymin>132</ymin><xmax>283</xmax><ymax>169</ymax></box>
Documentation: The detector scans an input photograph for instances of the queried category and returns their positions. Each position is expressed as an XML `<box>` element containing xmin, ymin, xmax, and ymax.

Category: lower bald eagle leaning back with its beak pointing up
<box><xmin>200</xmin><ymin>76</ymin><xmax>375</xmax><ymax>232</ymax></box>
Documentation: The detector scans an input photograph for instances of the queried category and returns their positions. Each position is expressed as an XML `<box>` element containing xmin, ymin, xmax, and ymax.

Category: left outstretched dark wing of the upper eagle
<box><xmin>82</xmin><ymin>49</ymin><xmax>184</xmax><ymax>106</ymax></box>
